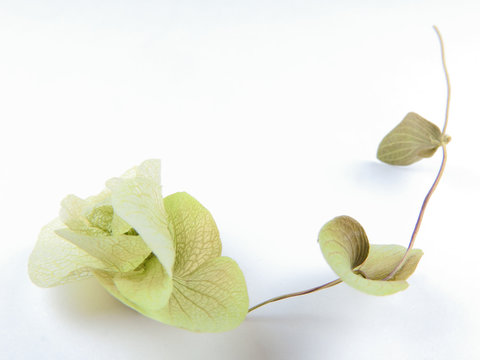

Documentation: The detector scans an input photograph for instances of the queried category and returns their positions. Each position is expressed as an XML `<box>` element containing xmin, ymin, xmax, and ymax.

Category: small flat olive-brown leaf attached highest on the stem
<box><xmin>377</xmin><ymin>112</ymin><xmax>450</xmax><ymax>165</ymax></box>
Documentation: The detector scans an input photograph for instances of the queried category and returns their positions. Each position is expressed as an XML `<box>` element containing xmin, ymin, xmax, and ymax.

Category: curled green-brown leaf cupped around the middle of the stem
<box><xmin>318</xmin><ymin>216</ymin><xmax>422</xmax><ymax>295</ymax></box>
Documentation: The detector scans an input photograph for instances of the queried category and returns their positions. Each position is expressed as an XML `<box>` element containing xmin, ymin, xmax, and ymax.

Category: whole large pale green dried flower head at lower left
<box><xmin>29</xmin><ymin>160</ymin><xmax>248</xmax><ymax>332</ymax></box>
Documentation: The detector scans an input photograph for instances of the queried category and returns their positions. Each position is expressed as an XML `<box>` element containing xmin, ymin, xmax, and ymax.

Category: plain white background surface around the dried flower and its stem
<box><xmin>0</xmin><ymin>0</ymin><xmax>480</xmax><ymax>360</ymax></box>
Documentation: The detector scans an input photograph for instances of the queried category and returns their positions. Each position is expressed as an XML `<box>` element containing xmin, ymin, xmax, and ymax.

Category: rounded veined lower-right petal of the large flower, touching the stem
<box><xmin>156</xmin><ymin>257</ymin><xmax>248</xmax><ymax>332</ymax></box>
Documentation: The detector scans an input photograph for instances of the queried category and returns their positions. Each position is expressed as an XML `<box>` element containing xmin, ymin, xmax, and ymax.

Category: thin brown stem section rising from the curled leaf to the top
<box><xmin>383</xmin><ymin>26</ymin><xmax>451</xmax><ymax>280</ymax></box>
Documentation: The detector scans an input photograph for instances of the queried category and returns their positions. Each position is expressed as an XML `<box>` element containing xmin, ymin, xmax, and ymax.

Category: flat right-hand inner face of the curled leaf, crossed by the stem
<box><xmin>358</xmin><ymin>245</ymin><xmax>423</xmax><ymax>280</ymax></box>
